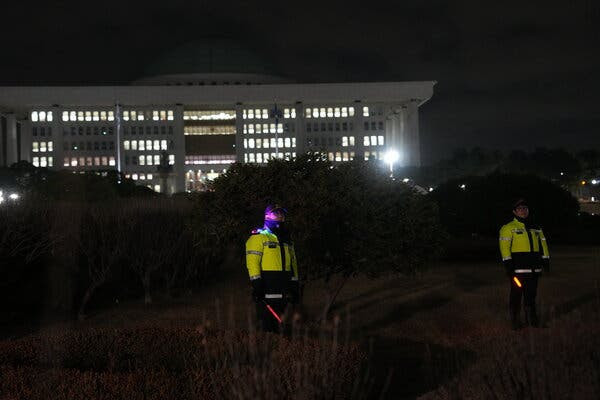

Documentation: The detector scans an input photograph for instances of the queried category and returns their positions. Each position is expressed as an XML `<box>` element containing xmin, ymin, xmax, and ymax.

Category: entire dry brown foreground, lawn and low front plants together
<box><xmin>0</xmin><ymin>247</ymin><xmax>600</xmax><ymax>399</ymax></box>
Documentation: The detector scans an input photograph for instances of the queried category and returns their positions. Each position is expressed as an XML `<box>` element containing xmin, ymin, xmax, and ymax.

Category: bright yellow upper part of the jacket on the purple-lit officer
<box><xmin>246</xmin><ymin>229</ymin><xmax>298</xmax><ymax>280</ymax></box>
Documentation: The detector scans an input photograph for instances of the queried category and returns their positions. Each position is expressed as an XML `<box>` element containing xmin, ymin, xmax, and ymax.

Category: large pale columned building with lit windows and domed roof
<box><xmin>0</xmin><ymin>43</ymin><xmax>435</xmax><ymax>193</ymax></box>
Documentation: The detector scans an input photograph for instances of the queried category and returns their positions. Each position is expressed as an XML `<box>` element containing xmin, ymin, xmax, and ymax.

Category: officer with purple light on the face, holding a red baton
<box><xmin>246</xmin><ymin>204</ymin><xmax>300</xmax><ymax>332</ymax></box>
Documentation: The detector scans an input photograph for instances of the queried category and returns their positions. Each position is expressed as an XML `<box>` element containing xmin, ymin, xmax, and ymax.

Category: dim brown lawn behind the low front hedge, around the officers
<box><xmin>1</xmin><ymin>247</ymin><xmax>600</xmax><ymax>399</ymax></box>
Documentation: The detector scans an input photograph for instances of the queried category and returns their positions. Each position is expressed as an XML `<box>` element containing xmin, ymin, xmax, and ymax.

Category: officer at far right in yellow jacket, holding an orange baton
<box><xmin>500</xmin><ymin>199</ymin><xmax>550</xmax><ymax>329</ymax></box>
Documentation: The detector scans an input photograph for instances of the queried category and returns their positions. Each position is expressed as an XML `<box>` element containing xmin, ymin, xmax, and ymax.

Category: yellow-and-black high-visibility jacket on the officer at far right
<box><xmin>500</xmin><ymin>218</ymin><xmax>550</xmax><ymax>273</ymax></box>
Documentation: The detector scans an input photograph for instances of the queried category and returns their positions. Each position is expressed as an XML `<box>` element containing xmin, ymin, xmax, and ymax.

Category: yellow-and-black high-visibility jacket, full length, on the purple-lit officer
<box><xmin>246</xmin><ymin>228</ymin><xmax>298</xmax><ymax>298</ymax></box>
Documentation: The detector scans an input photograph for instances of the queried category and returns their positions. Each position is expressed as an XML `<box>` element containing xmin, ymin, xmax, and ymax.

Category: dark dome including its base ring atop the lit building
<box><xmin>133</xmin><ymin>40</ymin><xmax>287</xmax><ymax>85</ymax></box>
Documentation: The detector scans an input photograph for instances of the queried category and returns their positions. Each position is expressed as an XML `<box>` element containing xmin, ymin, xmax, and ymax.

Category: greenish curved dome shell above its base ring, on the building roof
<box><xmin>144</xmin><ymin>40</ymin><xmax>279</xmax><ymax>77</ymax></box>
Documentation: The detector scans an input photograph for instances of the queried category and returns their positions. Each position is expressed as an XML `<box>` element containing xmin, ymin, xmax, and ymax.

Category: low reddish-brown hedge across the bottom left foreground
<box><xmin>0</xmin><ymin>327</ymin><xmax>364</xmax><ymax>399</ymax></box>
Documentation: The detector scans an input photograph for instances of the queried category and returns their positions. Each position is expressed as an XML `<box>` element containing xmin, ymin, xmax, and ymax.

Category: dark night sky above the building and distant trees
<box><xmin>0</xmin><ymin>0</ymin><xmax>600</xmax><ymax>162</ymax></box>
